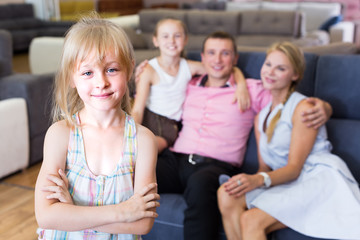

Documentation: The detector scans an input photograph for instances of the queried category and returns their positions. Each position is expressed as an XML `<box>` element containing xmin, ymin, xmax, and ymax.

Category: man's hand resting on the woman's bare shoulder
<box><xmin>301</xmin><ymin>97</ymin><xmax>332</xmax><ymax>129</ymax></box>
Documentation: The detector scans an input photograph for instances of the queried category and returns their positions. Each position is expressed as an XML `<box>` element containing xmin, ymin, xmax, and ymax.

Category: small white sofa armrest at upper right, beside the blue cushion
<box><xmin>329</xmin><ymin>21</ymin><xmax>355</xmax><ymax>43</ymax></box>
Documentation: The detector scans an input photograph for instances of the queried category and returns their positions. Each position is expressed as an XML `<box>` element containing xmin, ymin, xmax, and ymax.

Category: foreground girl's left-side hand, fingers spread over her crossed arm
<box><xmin>42</xmin><ymin>169</ymin><xmax>74</xmax><ymax>204</ymax></box>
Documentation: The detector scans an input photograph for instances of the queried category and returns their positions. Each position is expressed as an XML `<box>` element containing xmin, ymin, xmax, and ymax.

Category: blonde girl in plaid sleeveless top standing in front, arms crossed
<box><xmin>35</xmin><ymin>16</ymin><xmax>159</xmax><ymax>239</ymax></box>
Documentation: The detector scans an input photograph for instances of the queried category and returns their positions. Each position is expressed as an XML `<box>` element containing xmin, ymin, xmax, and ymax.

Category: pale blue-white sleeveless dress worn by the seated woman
<box><xmin>246</xmin><ymin>92</ymin><xmax>360</xmax><ymax>239</ymax></box>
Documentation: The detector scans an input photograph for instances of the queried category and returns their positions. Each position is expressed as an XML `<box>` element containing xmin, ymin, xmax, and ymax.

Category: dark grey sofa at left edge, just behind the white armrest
<box><xmin>0</xmin><ymin>30</ymin><xmax>54</xmax><ymax>165</ymax></box>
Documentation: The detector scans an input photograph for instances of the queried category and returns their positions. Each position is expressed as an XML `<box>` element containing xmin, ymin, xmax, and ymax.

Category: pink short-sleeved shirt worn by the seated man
<box><xmin>172</xmin><ymin>76</ymin><xmax>271</xmax><ymax>166</ymax></box>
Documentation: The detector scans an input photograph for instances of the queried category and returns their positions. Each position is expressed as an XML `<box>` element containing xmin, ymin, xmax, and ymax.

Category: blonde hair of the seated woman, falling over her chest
<box><xmin>266</xmin><ymin>42</ymin><xmax>306</xmax><ymax>142</ymax></box>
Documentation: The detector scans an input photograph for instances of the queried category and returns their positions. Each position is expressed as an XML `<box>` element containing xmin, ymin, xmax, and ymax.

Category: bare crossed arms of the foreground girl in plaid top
<box><xmin>35</xmin><ymin>122</ymin><xmax>159</xmax><ymax>234</ymax></box>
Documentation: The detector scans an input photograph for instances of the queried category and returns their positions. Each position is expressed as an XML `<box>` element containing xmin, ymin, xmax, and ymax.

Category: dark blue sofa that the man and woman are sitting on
<box><xmin>143</xmin><ymin>52</ymin><xmax>360</xmax><ymax>240</ymax></box>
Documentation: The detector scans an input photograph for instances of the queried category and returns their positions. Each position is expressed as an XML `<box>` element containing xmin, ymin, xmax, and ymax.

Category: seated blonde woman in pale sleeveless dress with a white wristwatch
<box><xmin>218</xmin><ymin>42</ymin><xmax>360</xmax><ymax>240</ymax></box>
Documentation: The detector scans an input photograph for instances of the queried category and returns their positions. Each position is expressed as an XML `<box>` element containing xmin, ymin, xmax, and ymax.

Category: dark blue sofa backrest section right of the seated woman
<box><xmin>315</xmin><ymin>55</ymin><xmax>360</xmax><ymax>182</ymax></box>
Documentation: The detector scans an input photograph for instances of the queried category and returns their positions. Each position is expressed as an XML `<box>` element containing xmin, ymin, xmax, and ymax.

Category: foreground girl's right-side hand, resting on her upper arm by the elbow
<box><xmin>118</xmin><ymin>183</ymin><xmax>160</xmax><ymax>222</ymax></box>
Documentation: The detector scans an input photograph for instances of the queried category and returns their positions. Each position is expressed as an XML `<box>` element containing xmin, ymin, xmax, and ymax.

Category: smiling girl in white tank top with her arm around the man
<box><xmin>131</xmin><ymin>18</ymin><xmax>249</xmax><ymax>152</ymax></box>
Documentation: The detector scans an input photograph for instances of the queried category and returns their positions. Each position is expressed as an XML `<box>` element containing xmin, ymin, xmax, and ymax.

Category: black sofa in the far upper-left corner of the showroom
<box><xmin>0</xmin><ymin>3</ymin><xmax>73</xmax><ymax>52</ymax></box>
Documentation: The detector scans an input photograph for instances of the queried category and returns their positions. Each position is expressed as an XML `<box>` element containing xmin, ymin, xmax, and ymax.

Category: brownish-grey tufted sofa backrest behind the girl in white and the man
<box><xmin>139</xmin><ymin>9</ymin><xmax>304</xmax><ymax>50</ymax></box>
